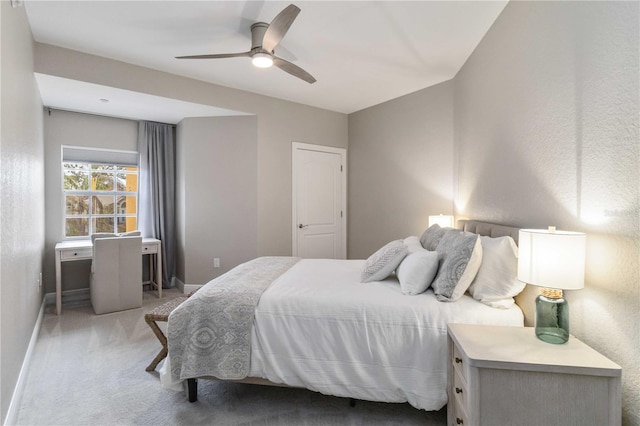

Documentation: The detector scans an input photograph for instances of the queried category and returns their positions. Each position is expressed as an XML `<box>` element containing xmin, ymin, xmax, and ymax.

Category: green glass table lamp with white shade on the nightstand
<box><xmin>518</xmin><ymin>226</ymin><xmax>587</xmax><ymax>344</ymax></box>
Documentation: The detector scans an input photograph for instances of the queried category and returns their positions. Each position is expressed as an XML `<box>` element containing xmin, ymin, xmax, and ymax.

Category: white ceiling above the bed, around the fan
<box><xmin>25</xmin><ymin>0</ymin><xmax>507</xmax><ymax>121</ymax></box>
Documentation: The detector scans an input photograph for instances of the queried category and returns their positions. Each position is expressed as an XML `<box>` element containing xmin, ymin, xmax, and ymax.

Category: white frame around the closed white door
<box><xmin>291</xmin><ymin>142</ymin><xmax>347</xmax><ymax>259</ymax></box>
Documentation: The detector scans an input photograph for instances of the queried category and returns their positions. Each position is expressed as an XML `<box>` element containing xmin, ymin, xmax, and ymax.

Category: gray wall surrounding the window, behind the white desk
<box><xmin>44</xmin><ymin>110</ymin><xmax>138</xmax><ymax>293</ymax></box>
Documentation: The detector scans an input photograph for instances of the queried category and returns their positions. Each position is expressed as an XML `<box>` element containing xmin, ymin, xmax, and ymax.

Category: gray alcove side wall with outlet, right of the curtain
<box><xmin>176</xmin><ymin>116</ymin><xmax>258</xmax><ymax>284</ymax></box>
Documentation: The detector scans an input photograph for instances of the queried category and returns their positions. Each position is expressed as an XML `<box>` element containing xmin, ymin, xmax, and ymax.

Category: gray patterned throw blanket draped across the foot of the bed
<box><xmin>167</xmin><ymin>257</ymin><xmax>300</xmax><ymax>380</ymax></box>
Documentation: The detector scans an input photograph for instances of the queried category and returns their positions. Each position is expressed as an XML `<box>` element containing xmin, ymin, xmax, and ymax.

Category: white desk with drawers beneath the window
<box><xmin>56</xmin><ymin>238</ymin><xmax>162</xmax><ymax>315</ymax></box>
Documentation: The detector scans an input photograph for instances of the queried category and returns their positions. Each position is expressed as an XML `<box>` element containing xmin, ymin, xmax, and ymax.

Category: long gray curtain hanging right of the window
<box><xmin>138</xmin><ymin>121</ymin><xmax>176</xmax><ymax>288</ymax></box>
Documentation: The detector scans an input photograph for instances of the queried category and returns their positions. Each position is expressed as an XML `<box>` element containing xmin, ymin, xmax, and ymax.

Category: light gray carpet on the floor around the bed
<box><xmin>17</xmin><ymin>290</ymin><xmax>446</xmax><ymax>426</ymax></box>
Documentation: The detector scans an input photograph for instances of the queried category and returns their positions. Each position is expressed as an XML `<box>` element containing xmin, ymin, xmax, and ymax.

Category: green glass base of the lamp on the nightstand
<box><xmin>535</xmin><ymin>289</ymin><xmax>569</xmax><ymax>345</ymax></box>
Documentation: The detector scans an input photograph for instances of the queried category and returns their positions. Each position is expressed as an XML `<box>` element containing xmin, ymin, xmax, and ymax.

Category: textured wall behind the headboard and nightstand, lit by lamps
<box><xmin>454</xmin><ymin>2</ymin><xmax>640</xmax><ymax>424</ymax></box>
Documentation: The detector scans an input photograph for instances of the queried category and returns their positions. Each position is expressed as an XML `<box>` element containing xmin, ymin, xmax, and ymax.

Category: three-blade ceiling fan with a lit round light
<box><xmin>176</xmin><ymin>4</ymin><xmax>316</xmax><ymax>84</ymax></box>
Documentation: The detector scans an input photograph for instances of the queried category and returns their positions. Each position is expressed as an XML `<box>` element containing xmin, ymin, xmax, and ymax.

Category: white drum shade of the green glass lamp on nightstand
<box><xmin>518</xmin><ymin>229</ymin><xmax>587</xmax><ymax>290</ymax></box>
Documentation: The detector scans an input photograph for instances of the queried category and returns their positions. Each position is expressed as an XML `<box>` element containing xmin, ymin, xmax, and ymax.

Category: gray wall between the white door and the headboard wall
<box><xmin>348</xmin><ymin>81</ymin><xmax>453</xmax><ymax>259</ymax></box>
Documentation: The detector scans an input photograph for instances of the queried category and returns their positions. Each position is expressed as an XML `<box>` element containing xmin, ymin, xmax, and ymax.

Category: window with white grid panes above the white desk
<box><xmin>62</xmin><ymin>161</ymin><xmax>138</xmax><ymax>238</ymax></box>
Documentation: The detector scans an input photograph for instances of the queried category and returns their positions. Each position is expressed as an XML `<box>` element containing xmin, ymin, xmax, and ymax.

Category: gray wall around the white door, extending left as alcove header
<box><xmin>35</xmin><ymin>43</ymin><xmax>348</xmax><ymax>255</ymax></box>
